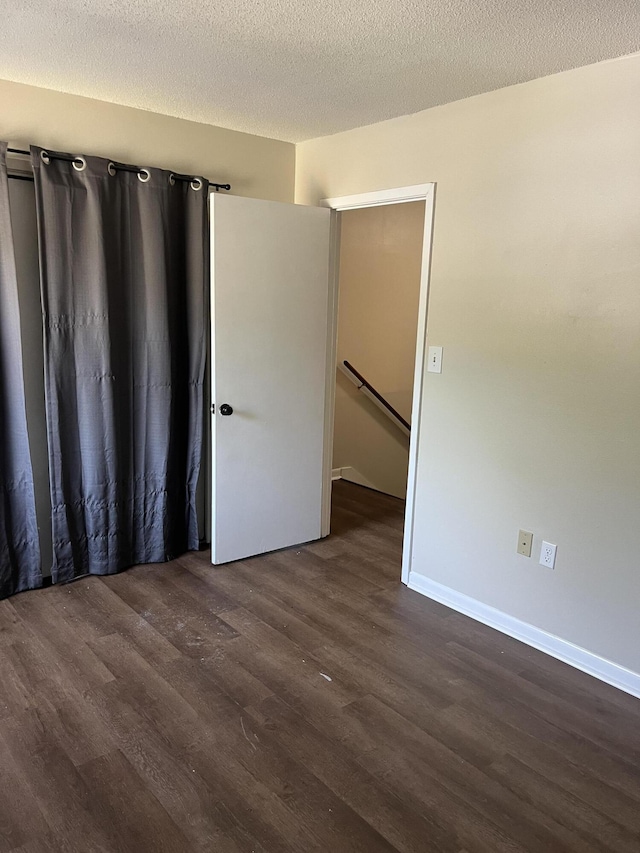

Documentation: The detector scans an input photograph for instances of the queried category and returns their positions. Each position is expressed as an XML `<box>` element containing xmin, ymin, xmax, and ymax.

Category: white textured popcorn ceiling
<box><xmin>0</xmin><ymin>0</ymin><xmax>640</xmax><ymax>141</ymax></box>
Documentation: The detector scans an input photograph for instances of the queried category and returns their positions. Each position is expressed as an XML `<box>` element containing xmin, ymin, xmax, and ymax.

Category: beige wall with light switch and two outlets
<box><xmin>297</xmin><ymin>56</ymin><xmax>640</xmax><ymax>672</ymax></box>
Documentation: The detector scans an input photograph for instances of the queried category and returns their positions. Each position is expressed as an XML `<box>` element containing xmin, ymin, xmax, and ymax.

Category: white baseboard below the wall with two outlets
<box><xmin>407</xmin><ymin>572</ymin><xmax>640</xmax><ymax>699</ymax></box>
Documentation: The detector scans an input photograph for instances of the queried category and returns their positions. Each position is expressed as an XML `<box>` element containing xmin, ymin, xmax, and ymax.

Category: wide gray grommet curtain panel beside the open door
<box><xmin>31</xmin><ymin>148</ymin><xmax>209</xmax><ymax>582</ymax></box>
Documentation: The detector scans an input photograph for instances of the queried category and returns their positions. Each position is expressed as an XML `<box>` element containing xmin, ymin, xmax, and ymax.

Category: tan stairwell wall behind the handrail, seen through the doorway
<box><xmin>333</xmin><ymin>202</ymin><xmax>424</xmax><ymax>497</ymax></box>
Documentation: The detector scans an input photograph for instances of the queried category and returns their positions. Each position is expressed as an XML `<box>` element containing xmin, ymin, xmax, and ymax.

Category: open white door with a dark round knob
<box><xmin>211</xmin><ymin>194</ymin><xmax>331</xmax><ymax>564</ymax></box>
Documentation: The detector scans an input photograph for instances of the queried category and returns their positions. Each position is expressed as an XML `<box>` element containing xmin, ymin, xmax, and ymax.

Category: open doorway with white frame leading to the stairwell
<box><xmin>324</xmin><ymin>184</ymin><xmax>435</xmax><ymax>582</ymax></box>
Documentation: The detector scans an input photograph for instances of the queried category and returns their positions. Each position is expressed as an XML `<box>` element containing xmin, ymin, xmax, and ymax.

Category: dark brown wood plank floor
<box><xmin>0</xmin><ymin>482</ymin><xmax>640</xmax><ymax>853</ymax></box>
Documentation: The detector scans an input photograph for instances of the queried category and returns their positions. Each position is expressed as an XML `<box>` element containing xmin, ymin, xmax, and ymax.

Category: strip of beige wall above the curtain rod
<box><xmin>0</xmin><ymin>80</ymin><xmax>295</xmax><ymax>201</ymax></box>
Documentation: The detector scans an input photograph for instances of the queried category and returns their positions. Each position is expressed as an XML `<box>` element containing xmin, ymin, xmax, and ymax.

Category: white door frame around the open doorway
<box><xmin>320</xmin><ymin>183</ymin><xmax>436</xmax><ymax>584</ymax></box>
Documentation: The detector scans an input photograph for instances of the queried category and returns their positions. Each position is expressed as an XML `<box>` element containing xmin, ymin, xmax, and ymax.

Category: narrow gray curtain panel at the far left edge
<box><xmin>0</xmin><ymin>142</ymin><xmax>42</xmax><ymax>598</ymax></box>
